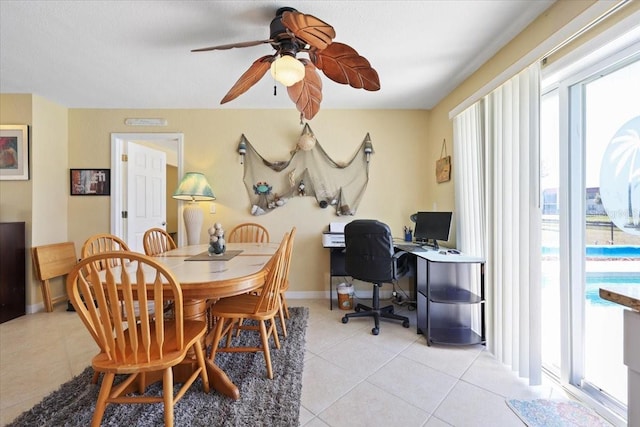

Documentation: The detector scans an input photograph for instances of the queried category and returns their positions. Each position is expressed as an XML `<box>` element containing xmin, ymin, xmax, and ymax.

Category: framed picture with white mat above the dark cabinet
<box><xmin>0</xmin><ymin>125</ymin><xmax>29</xmax><ymax>181</ymax></box>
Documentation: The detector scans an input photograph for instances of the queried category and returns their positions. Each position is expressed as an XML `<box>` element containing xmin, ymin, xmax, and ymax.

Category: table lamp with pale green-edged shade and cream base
<box><xmin>172</xmin><ymin>172</ymin><xmax>216</xmax><ymax>245</ymax></box>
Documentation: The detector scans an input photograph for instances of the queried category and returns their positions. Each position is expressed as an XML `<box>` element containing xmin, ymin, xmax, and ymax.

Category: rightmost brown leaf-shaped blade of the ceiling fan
<box><xmin>309</xmin><ymin>42</ymin><xmax>380</xmax><ymax>91</ymax></box>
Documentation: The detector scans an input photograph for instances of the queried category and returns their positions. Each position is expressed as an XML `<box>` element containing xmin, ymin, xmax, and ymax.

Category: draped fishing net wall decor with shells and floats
<box><xmin>238</xmin><ymin>124</ymin><xmax>373</xmax><ymax>215</ymax></box>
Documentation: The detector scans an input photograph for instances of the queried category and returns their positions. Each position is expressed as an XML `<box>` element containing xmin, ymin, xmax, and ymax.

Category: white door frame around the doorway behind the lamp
<box><xmin>110</xmin><ymin>133</ymin><xmax>184</xmax><ymax>245</ymax></box>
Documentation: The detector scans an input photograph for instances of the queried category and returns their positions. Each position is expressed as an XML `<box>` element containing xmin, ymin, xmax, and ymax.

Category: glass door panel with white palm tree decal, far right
<box><xmin>570</xmin><ymin>61</ymin><xmax>640</xmax><ymax>410</ymax></box>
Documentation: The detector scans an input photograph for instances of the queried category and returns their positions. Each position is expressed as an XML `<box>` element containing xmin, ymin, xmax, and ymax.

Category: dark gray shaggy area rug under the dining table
<box><xmin>8</xmin><ymin>307</ymin><xmax>309</xmax><ymax>427</ymax></box>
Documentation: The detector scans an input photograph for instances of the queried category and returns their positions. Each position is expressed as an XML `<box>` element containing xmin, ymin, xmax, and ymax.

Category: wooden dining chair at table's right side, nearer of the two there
<box><xmin>209</xmin><ymin>233</ymin><xmax>289</xmax><ymax>379</ymax></box>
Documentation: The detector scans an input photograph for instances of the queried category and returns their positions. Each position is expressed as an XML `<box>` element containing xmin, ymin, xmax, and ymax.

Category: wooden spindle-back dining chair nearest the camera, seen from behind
<box><xmin>67</xmin><ymin>251</ymin><xmax>209</xmax><ymax>427</ymax></box>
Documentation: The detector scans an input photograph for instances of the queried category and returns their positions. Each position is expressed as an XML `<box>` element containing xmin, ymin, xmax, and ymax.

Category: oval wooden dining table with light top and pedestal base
<box><xmin>153</xmin><ymin>243</ymin><xmax>279</xmax><ymax>399</ymax></box>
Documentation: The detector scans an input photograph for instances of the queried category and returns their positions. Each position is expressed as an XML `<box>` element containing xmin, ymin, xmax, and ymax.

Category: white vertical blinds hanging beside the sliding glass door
<box><xmin>454</xmin><ymin>64</ymin><xmax>542</xmax><ymax>384</ymax></box>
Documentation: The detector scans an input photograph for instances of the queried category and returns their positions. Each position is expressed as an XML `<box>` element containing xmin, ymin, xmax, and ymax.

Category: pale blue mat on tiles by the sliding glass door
<box><xmin>506</xmin><ymin>399</ymin><xmax>612</xmax><ymax>427</ymax></box>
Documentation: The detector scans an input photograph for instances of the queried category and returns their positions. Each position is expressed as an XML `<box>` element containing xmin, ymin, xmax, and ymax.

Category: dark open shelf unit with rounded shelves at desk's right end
<box><xmin>416</xmin><ymin>253</ymin><xmax>485</xmax><ymax>345</ymax></box>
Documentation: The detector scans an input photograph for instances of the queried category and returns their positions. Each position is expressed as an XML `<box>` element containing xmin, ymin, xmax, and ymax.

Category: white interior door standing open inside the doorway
<box><xmin>126</xmin><ymin>141</ymin><xmax>167</xmax><ymax>252</ymax></box>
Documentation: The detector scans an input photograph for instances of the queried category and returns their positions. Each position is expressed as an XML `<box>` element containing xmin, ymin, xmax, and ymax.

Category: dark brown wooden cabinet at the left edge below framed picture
<box><xmin>0</xmin><ymin>222</ymin><xmax>26</xmax><ymax>323</ymax></box>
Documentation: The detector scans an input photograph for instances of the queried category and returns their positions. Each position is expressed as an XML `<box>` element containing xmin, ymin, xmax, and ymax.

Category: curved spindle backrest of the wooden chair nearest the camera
<box><xmin>67</xmin><ymin>251</ymin><xmax>185</xmax><ymax>365</ymax></box>
